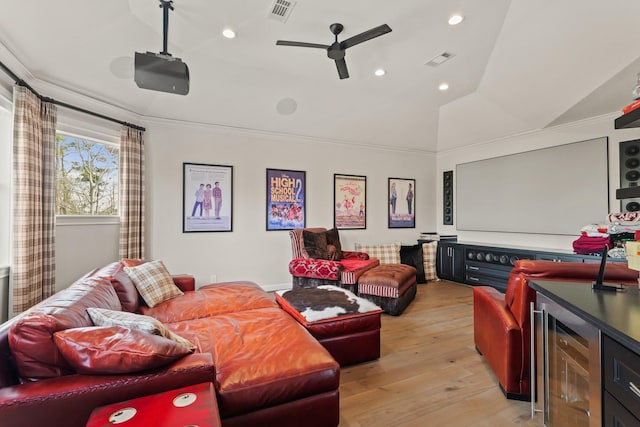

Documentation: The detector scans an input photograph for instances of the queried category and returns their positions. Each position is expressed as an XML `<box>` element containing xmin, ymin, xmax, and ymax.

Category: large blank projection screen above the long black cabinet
<box><xmin>455</xmin><ymin>137</ymin><xmax>609</xmax><ymax>235</ymax></box>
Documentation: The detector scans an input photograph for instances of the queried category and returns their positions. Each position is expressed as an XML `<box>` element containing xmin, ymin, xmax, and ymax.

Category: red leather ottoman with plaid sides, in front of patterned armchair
<box><xmin>358</xmin><ymin>264</ymin><xmax>417</xmax><ymax>316</ymax></box>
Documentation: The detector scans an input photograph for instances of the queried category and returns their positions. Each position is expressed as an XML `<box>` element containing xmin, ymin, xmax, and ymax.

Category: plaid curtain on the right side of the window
<box><xmin>120</xmin><ymin>126</ymin><xmax>144</xmax><ymax>258</ymax></box>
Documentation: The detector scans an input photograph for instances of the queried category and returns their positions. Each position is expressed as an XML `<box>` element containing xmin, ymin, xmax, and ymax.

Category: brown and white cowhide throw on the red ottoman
<box><xmin>278</xmin><ymin>285</ymin><xmax>380</xmax><ymax>322</ymax></box>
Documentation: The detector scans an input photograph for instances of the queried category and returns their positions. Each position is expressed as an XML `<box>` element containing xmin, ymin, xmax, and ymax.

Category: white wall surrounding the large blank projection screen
<box><xmin>437</xmin><ymin>113</ymin><xmax>640</xmax><ymax>251</ymax></box>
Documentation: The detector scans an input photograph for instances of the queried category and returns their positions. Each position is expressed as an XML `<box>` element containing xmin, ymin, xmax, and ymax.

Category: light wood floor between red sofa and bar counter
<box><xmin>340</xmin><ymin>281</ymin><xmax>542</xmax><ymax>427</ymax></box>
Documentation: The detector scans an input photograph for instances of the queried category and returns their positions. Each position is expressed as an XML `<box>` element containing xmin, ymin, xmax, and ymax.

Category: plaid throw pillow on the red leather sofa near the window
<box><xmin>124</xmin><ymin>260</ymin><xmax>183</xmax><ymax>307</ymax></box>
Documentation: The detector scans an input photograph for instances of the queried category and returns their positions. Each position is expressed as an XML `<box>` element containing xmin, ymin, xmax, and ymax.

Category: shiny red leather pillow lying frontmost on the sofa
<box><xmin>53</xmin><ymin>326</ymin><xmax>191</xmax><ymax>374</ymax></box>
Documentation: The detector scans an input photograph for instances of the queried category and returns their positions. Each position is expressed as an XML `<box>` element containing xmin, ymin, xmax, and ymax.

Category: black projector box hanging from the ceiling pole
<box><xmin>134</xmin><ymin>52</ymin><xmax>189</xmax><ymax>95</ymax></box>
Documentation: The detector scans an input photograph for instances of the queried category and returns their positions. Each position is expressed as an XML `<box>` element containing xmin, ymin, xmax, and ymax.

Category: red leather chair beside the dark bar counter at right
<box><xmin>473</xmin><ymin>260</ymin><xmax>638</xmax><ymax>400</ymax></box>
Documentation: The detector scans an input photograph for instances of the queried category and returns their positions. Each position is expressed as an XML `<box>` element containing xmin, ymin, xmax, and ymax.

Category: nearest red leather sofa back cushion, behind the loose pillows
<box><xmin>9</xmin><ymin>277</ymin><xmax>122</xmax><ymax>381</ymax></box>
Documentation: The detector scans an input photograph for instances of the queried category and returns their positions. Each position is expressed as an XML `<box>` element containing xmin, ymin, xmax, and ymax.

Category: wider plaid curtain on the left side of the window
<box><xmin>10</xmin><ymin>86</ymin><xmax>57</xmax><ymax>315</ymax></box>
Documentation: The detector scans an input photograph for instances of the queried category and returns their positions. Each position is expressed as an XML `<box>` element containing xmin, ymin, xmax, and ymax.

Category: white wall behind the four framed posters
<box><xmin>145</xmin><ymin>121</ymin><xmax>436</xmax><ymax>289</ymax></box>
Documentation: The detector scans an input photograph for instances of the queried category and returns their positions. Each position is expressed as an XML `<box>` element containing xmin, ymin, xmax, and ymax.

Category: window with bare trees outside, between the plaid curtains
<box><xmin>56</xmin><ymin>132</ymin><xmax>119</xmax><ymax>215</ymax></box>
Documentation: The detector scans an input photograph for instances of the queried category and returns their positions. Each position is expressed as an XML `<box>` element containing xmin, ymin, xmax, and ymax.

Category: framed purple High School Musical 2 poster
<box><xmin>267</xmin><ymin>169</ymin><xmax>307</xmax><ymax>231</ymax></box>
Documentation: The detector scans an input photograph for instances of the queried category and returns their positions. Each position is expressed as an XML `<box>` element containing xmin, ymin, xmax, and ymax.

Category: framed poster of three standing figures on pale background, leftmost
<box><xmin>182</xmin><ymin>163</ymin><xmax>233</xmax><ymax>233</ymax></box>
